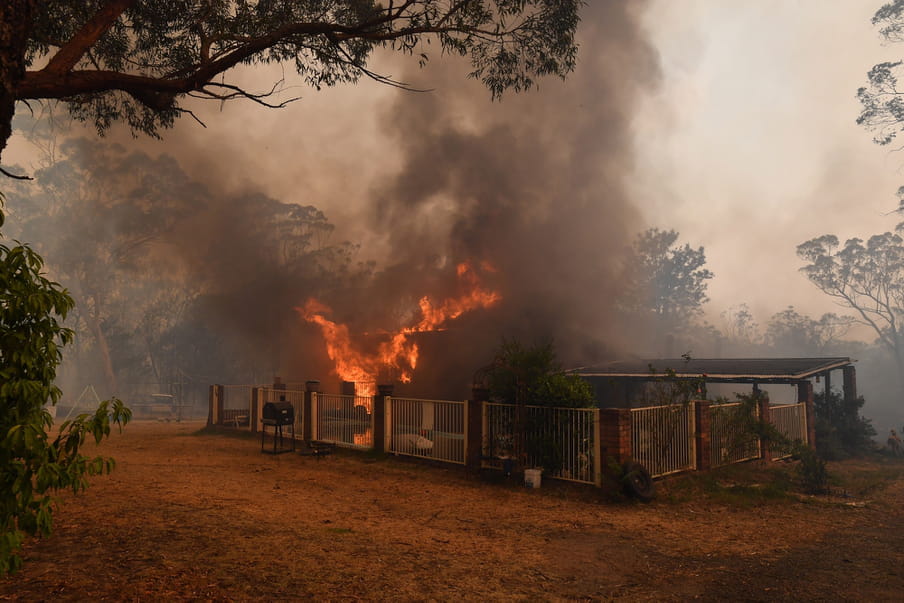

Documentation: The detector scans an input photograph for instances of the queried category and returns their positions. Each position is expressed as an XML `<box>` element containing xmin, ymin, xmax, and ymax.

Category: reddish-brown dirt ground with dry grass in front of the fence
<box><xmin>0</xmin><ymin>422</ymin><xmax>904</xmax><ymax>601</ymax></box>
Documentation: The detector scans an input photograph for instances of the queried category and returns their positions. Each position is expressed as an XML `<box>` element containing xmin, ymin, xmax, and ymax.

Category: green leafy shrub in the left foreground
<box><xmin>0</xmin><ymin>202</ymin><xmax>131</xmax><ymax>573</ymax></box>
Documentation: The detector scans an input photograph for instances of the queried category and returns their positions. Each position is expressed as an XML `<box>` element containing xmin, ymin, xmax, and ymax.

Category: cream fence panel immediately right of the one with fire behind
<box><xmin>386</xmin><ymin>398</ymin><xmax>467</xmax><ymax>464</ymax></box>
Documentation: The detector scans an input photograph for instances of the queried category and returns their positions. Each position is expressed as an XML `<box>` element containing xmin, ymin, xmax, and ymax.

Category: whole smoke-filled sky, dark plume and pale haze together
<box><xmin>8</xmin><ymin>0</ymin><xmax>904</xmax><ymax>430</ymax></box>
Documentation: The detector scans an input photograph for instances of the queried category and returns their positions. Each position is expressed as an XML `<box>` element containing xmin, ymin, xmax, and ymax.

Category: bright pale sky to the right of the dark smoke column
<box><xmin>634</xmin><ymin>0</ymin><xmax>904</xmax><ymax>325</ymax></box>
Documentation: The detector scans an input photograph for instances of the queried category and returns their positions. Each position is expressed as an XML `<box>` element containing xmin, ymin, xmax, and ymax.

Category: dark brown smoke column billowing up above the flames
<box><xmin>350</xmin><ymin>2</ymin><xmax>658</xmax><ymax>396</ymax></box>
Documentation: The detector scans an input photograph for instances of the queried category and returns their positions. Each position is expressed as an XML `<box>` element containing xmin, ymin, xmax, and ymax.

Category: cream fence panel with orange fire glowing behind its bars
<box><xmin>311</xmin><ymin>394</ymin><xmax>374</xmax><ymax>449</ymax></box>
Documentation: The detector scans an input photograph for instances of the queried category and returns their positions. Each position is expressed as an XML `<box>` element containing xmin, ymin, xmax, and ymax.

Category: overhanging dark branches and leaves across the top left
<box><xmin>0</xmin><ymin>0</ymin><xmax>582</xmax><ymax>163</ymax></box>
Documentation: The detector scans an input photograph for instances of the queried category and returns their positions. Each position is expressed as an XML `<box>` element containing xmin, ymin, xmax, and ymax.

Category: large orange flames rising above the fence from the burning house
<box><xmin>296</xmin><ymin>262</ymin><xmax>502</xmax><ymax>396</ymax></box>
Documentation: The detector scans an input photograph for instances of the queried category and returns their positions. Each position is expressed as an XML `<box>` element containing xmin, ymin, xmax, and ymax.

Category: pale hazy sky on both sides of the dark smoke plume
<box><xmin>6</xmin><ymin>0</ymin><xmax>904</xmax><ymax>340</ymax></box>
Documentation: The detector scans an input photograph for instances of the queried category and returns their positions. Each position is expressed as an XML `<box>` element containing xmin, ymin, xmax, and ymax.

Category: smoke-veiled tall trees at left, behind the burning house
<box><xmin>7</xmin><ymin>124</ymin><xmax>369</xmax><ymax>399</ymax></box>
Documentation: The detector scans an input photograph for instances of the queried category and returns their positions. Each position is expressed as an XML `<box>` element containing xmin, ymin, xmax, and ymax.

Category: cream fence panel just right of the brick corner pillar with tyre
<box><xmin>631</xmin><ymin>402</ymin><xmax>697</xmax><ymax>477</ymax></box>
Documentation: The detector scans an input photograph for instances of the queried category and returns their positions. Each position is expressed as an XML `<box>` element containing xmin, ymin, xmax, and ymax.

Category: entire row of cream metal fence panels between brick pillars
<box><xmin>211</xmin><ymin>385</ymin><xmax>820</xmax><ymax>484</ymax></box>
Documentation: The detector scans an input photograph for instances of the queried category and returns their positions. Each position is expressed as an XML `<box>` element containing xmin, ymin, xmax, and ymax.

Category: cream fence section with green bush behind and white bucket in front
<box><xmin>483</xmin><ymin>402</ymin><xmax>599</xmax><ymax>484</ymax></box>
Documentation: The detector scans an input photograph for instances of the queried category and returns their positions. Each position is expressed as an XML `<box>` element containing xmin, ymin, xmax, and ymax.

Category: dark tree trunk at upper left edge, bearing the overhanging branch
<box><xmin>0</xmin><ymin>0</ymin><xmax>37</xmax><ymax>164</ymax></box>
